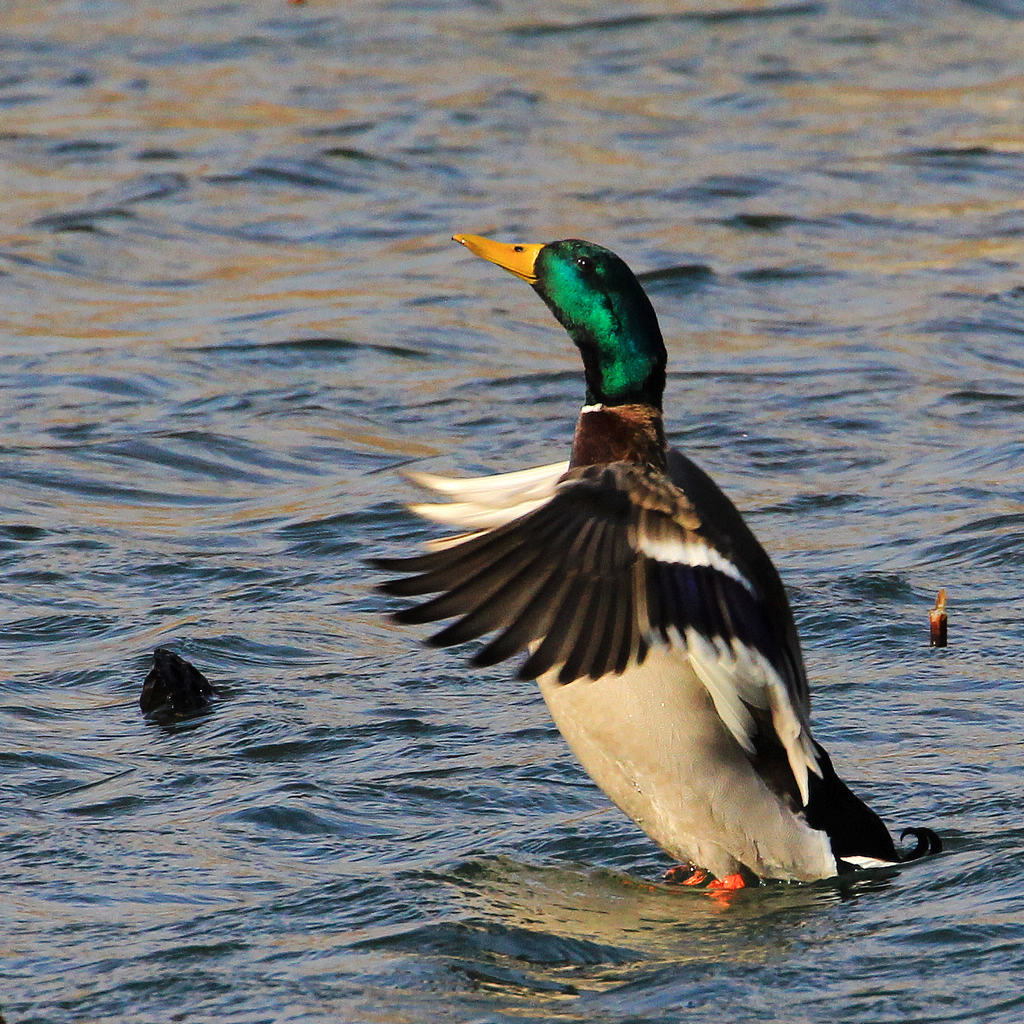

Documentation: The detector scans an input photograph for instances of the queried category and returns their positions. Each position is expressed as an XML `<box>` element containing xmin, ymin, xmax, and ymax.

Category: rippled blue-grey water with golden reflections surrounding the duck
<box><xmin>6</xmin><ymin>0</ymin><xmax>1024</xmax><ymax>1024</ymax></box>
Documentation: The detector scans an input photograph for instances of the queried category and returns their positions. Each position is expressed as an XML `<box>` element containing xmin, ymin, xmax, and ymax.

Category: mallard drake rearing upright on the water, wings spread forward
<box><xmin>375</xmin><ymin>234</ymin><xmax>938</xmax><ymax>889</ymax></box>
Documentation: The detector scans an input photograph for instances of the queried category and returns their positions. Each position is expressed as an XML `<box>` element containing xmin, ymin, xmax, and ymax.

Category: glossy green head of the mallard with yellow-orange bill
<box><xmin>454</xmin><ymin>234</ymin><xmax>666</xmax><ymax>409</ymax></box>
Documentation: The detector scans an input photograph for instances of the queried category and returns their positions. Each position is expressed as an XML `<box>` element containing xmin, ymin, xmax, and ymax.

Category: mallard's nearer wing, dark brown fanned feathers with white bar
<box><xmin>376</xmin><ymin>463</ymin><xmax>802</xmax><ymax>683</ymax></box>
